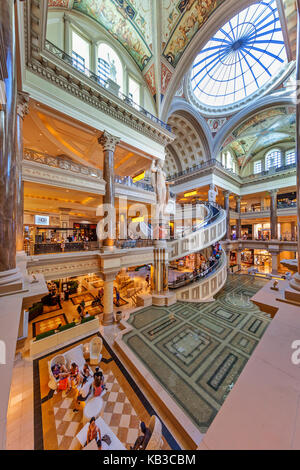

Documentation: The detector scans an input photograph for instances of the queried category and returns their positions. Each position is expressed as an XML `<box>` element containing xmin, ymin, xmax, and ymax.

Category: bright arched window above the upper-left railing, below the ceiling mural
<box><xmin>97</xmin><ymin>43</ymin><xmax>123</xmax><ymax>91</ymax></box>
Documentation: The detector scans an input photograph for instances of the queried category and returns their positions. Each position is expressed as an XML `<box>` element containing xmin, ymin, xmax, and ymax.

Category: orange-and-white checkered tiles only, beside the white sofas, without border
<box><xmin>52</xmin><ymin>371</ymin><xmax>140</xmax><ymax>450</ymax></box>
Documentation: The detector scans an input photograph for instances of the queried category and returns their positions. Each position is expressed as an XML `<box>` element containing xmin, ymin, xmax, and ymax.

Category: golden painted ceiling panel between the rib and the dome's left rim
<box><xmin>162</xmin><ymin>0</ymin><xmax>225</xmax><ymax>67</ymax></box>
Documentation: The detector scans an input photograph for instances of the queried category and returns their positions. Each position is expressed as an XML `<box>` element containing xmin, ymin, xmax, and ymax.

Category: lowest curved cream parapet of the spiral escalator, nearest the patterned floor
<box><xmin>176</xmin><ymin>251</ymin><xmax>227</xmax><ymax>302</ymax></box>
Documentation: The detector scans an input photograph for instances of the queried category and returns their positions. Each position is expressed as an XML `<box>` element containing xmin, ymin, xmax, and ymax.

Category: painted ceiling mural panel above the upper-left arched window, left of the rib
<box><xmin>73</xmin><ymin>0</ymin><xmax>152</xmax><ymax>70</ymax></box>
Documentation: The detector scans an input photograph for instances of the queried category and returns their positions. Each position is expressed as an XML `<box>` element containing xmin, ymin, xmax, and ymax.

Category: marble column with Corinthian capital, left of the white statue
<box><xmin>98</xmin><ymin>131</ymin><xmax>120</xmax><ymax>251</ymax></box>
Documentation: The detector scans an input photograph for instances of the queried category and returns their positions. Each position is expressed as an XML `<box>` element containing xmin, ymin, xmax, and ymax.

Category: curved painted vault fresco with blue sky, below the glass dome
<box><xmin>223</xmin><ymin>107</ymin><xmax>296</xmax><ymax>166</ymax></box>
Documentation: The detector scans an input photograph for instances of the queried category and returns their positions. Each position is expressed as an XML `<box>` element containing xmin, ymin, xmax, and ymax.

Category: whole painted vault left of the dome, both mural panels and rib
<box><xmin>48</xmin><ymin>0</ymin><xmax>225</xmax><ymax>103</ymax></box>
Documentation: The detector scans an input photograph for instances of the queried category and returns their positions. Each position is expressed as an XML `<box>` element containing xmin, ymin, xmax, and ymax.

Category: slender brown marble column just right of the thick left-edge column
<box><xmin>16</xmin><ymin>92</ymin><xmax>29</xmax><ymax>252</ymax></box>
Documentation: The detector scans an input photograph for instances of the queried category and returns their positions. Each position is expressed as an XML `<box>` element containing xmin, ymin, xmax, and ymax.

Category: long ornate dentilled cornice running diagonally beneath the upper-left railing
<box><xmin>24</xmin><ymin>0</ymin><xmax>174</xmax><ymax>146</ymax></box>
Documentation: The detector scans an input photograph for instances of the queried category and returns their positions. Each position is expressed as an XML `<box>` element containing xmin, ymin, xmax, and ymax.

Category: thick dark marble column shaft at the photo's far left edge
<box><xmin>0</xmin><ymin>0</ymin><xmax>17</xmax><ymax>271</ymax></box>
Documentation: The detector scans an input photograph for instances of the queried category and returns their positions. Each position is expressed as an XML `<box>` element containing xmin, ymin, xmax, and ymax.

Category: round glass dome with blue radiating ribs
<box><xmin>191</xmin><ymin>0</ymin><xmax>287</xmax><ymax>107</ymax></box>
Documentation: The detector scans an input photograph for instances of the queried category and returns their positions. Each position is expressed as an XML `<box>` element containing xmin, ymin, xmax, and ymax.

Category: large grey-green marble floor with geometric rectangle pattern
<box><xmin>124</xmin><ymin>275</ymin><xmax>271</xmax><ymax>432</ymax></box>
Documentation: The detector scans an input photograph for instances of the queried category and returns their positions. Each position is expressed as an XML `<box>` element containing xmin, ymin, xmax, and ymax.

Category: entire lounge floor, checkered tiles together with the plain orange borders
<box><xmin>34</xmin><ymin>336</ymin><xmax>176</xmax><ymax>450</ymax></box>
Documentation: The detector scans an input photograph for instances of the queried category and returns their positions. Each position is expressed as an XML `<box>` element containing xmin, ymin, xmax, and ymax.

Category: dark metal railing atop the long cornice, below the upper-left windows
<box><xmin>45</xmin><ymin>40</ymin><xmax>172</xmax><ymax>132</ymax></box>
